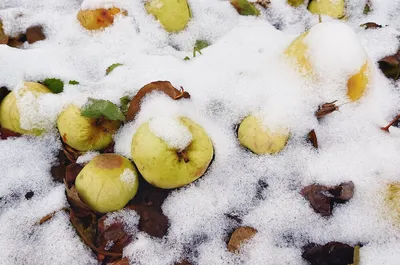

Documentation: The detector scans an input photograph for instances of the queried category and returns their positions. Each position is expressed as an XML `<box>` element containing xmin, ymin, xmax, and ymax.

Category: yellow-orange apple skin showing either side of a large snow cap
<box><xmin>284</xmin><ymin>24</ymin><xmax>371</xmax><ymax>101</ymax></box>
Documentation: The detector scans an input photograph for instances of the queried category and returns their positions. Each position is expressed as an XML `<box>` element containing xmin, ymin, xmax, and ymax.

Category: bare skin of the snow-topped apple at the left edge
<box><xmin>0</xmin><ymin>82</ymin><xmax>51</xmax><ymax>136</ymax></box>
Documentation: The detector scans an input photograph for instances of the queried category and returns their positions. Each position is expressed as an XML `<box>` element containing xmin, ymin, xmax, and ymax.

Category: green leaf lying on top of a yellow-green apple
<box><xmin>81</xmin><ymin>98</ymin><xmax>125</xmax><ymax>121</ymax></box>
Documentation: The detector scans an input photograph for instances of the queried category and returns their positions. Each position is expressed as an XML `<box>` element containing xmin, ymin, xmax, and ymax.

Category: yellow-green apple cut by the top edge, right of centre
<box><xmin>308</xmin><ymin>0</ymin><xmax>345</xmax><ymax>18</ymax></box>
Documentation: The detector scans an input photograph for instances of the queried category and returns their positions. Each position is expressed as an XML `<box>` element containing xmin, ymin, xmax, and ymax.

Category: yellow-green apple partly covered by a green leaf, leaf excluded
<box><xmin>57</xmin><ymin>105</ymin><xmax>121</xmax><ymax>151</ymax></box>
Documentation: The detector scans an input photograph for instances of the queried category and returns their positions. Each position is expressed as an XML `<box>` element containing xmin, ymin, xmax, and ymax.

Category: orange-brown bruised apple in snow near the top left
<box><xmin>77</xmin><ymin>7</ymin><xmax>125</xmax><ymax>30</ymax></box>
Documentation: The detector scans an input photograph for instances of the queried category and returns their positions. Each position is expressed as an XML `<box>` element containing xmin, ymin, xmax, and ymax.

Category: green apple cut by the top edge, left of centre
<box><xmin>145</xmin><ymin>0</ymin><xmax>191</xmax><ymax>32</ymax></box>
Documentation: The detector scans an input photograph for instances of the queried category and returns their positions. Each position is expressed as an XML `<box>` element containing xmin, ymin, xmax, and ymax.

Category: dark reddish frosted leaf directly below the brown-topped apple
<box><xmin>97</xmin><ymin>215</ymin><xmax>132</xmax><ymax>254</ymax></box>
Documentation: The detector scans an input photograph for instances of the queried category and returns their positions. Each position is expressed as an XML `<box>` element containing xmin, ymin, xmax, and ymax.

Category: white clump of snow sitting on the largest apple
<box><xmin>149</xmin><ymin>117</ymin><xmax>193</xmax><ymax>150</ymax></box>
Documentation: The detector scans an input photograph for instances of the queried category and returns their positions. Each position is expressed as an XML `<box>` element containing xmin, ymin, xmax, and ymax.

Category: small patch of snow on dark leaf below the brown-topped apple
<box><xmin>104</xmin><ymin>209</ymin><xmax>140</xmax><ymax>235</ymax></box>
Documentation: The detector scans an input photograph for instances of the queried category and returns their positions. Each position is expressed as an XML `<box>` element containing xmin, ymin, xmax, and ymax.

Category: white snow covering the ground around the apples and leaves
<box><xmin>0</xmin><ymin>0</ymin><xmax>400</xmax><ymax>265</ymax></box>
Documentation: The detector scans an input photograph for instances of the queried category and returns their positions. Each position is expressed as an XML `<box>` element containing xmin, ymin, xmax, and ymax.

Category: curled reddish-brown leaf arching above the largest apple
<box><xmin>127</xmin><ymin>81</ymin><xmax>190</xmax><ymax>121</ymax></box>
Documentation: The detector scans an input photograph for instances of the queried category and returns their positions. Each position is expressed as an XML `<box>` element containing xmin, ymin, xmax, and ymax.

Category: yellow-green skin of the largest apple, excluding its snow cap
<box><xmin>131</xmin><ymin>118</ymin><xmax>214</xmax><ymax>189</ymax></box>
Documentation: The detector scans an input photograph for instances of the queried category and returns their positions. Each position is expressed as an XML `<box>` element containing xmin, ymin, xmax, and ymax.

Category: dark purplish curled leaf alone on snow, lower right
<box><xmin>300</xmin><ymin>181</ymin><xmax>354</xmax><ymax>216</ymax></box>
